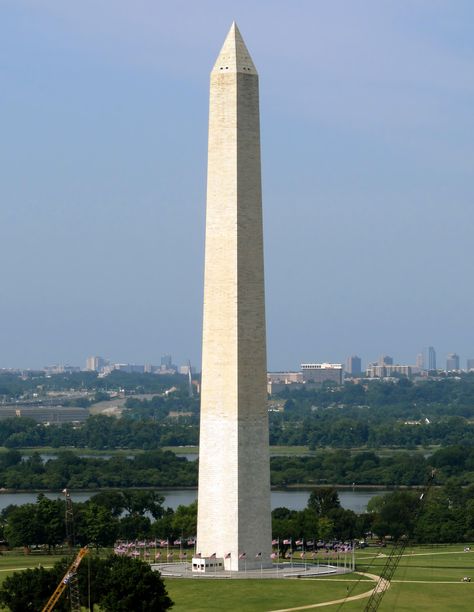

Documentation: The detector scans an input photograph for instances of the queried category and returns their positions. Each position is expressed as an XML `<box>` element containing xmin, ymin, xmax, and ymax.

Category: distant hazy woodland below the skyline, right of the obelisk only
<box><xmin>270</xmin><ymin>374</ymin><xmax>474</xmax><ymax>449</ymax></box>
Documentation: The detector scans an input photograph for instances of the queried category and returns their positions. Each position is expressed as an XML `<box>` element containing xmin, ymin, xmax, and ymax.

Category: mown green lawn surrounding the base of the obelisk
<box><xmin>0</xmin><ymin>544</ymin><xmax>474</xmax><ymax>612</ymax></box>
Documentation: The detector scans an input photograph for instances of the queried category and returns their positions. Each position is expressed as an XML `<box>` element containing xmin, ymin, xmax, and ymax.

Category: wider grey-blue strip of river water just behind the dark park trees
<box><xmin>0</xmin><ymin>489</ymin><xmax>386</xmax><ymax>513</ymax></box>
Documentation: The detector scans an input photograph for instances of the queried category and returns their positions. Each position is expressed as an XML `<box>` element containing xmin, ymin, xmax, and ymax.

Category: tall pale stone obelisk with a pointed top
<box><xmin>196</xmin><ymin>23</ymin><xmax>271</xmax><ymax>570</ymax></box>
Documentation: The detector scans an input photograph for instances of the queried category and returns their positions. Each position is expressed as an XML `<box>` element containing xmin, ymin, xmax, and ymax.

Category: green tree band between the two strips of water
<box><xmin>0</xmin><ymin>446</ymin><xmax>474</xmax><ymax>490</ymax></box>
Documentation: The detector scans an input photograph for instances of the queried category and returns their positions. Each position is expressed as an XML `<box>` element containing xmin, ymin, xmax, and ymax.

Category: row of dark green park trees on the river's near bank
<box><xmin>0</xmin><ymin>479</ymin><xmax>474</xmax><ymax>552</ymax></box>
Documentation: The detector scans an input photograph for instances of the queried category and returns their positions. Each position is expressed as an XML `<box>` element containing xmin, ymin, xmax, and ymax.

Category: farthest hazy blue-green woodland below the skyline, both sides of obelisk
<box><xmin>4</xmin><ymin>372</ymin><xmax>474</xmax><ymax>449</ymax></box>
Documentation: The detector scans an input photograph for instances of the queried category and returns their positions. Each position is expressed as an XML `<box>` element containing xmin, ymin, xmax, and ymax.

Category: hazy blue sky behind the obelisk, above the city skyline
<box><xmin>0</xmin><ymin>0</ymin><xmax>474</xmax><ymax>369</ymax></box>
